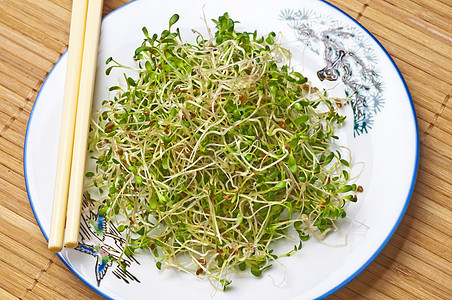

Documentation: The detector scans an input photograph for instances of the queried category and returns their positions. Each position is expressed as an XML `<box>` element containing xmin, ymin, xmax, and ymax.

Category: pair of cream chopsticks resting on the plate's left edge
<box><xmin>48</xmin><ymin>0</ymin><xmax>103</xmax><ymax>252</ymax></box>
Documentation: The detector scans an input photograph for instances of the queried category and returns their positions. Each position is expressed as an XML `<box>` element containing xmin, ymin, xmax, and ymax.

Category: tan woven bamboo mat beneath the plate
<box><xmin>0</xmin><ymin>0</ymin><xmax>452</xmax><ymax>299</ymax></box>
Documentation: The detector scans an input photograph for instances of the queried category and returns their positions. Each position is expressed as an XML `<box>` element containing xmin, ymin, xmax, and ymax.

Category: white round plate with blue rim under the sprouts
<box><xmin>24</xmin><ymin>0</ymin><xmax>419</xmax><ymax>300</ymax></box>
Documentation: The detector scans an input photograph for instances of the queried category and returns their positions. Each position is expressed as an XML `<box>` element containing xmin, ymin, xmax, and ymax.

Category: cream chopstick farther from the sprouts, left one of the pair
<box><xmin>48</xmin><ymin>0</ymin><xmax>88</xmax><ymax>252</ymax></box>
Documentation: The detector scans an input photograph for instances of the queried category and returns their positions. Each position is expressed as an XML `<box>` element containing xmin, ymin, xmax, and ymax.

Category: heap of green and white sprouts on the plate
<box><xmin>87</xmin><ymin>13</ymin><xmax>360</xmax><ymax>289</ymax></box>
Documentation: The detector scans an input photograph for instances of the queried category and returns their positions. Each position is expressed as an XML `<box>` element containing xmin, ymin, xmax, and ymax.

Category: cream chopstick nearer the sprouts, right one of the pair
<box><xmin>64</xmin><ymin>0</ymin><xmax>103</xmax><ymax>248</ymax></box>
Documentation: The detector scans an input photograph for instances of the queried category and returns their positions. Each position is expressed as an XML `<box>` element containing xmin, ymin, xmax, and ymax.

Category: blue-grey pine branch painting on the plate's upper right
<box><xmin>280</xmin><ymin>9</ymin><xmax>384</xmax><ymax>136</ymax></box>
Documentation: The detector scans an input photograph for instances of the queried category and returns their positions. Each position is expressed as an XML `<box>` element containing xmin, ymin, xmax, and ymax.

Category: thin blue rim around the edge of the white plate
<box><xmin>23</xmin><ymin>0</ymin><xmax>419</xmax><ymax>299</ymax></box>
